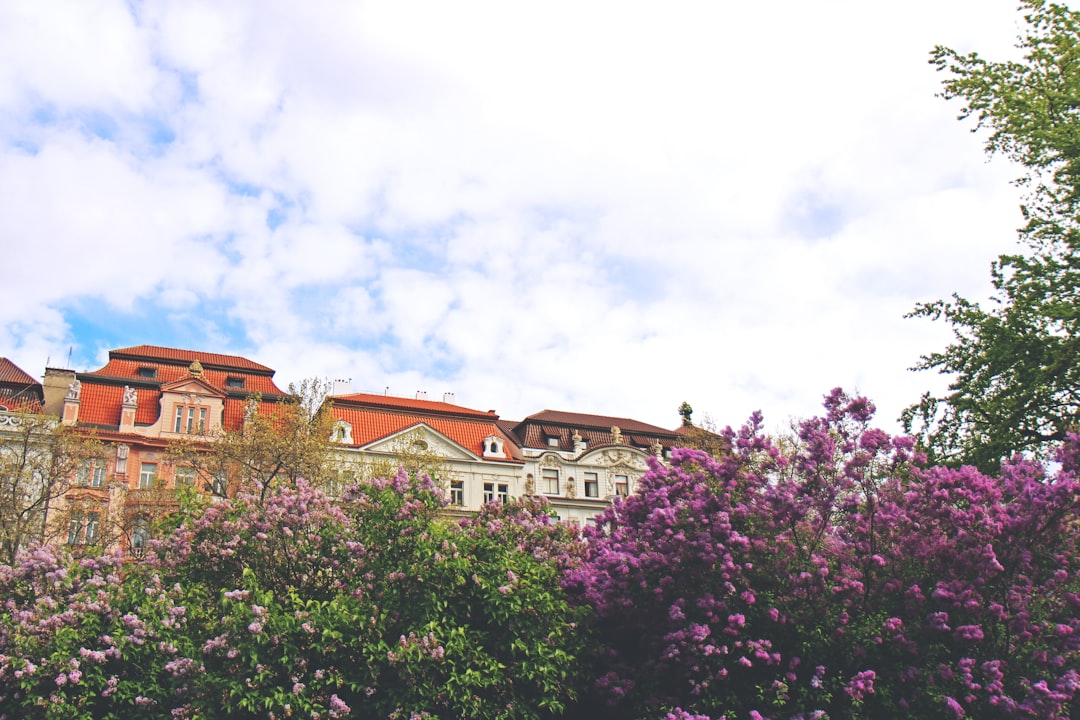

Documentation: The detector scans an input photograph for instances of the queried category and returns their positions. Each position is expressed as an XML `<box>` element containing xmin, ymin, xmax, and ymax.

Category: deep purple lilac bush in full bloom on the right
<box><xmin>566</xmin><ymin>391</ymin><xmax>1080</xmax><ymax>720</ymax></box>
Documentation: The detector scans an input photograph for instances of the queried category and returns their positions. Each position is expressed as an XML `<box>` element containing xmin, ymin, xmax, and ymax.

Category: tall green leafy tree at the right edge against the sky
<box><xmin>902</xmin><ymin>0</ymin><xmax>1080</xmax><ymax>470</ymax></box>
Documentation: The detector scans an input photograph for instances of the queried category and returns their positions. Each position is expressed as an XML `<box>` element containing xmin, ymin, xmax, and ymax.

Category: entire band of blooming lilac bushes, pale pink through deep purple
<box><xmin>0</xmin><ymin>391</ymin><xmax>1080</xmax><ymax>720</ymax></box>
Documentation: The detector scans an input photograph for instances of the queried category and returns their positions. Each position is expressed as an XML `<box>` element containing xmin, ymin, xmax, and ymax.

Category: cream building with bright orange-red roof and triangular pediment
<box><xmin>330</xmin><ymin>393</ymin><xmax>525</xmax><ymax>513</ymax></box>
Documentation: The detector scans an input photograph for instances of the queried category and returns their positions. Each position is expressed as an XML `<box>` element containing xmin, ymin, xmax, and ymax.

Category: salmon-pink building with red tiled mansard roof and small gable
<box><xmin>44</xmin><ymin>345</ymin><xmax>285</xmax><ymax>552</ymax></box>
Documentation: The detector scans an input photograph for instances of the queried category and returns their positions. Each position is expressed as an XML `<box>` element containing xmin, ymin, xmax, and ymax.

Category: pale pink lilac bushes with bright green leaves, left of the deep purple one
<box><xmin>0</xmin><ymin>473</ymin><xmax>582</xmax><ymax>720</ymax></box>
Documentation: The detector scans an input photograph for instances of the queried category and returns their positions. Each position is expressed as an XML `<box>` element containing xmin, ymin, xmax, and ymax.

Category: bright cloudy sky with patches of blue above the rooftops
<box><xmin>0</xmin><ymin>0</ymin><xmax>1045</xmax><ymax>431</ymax></box>
